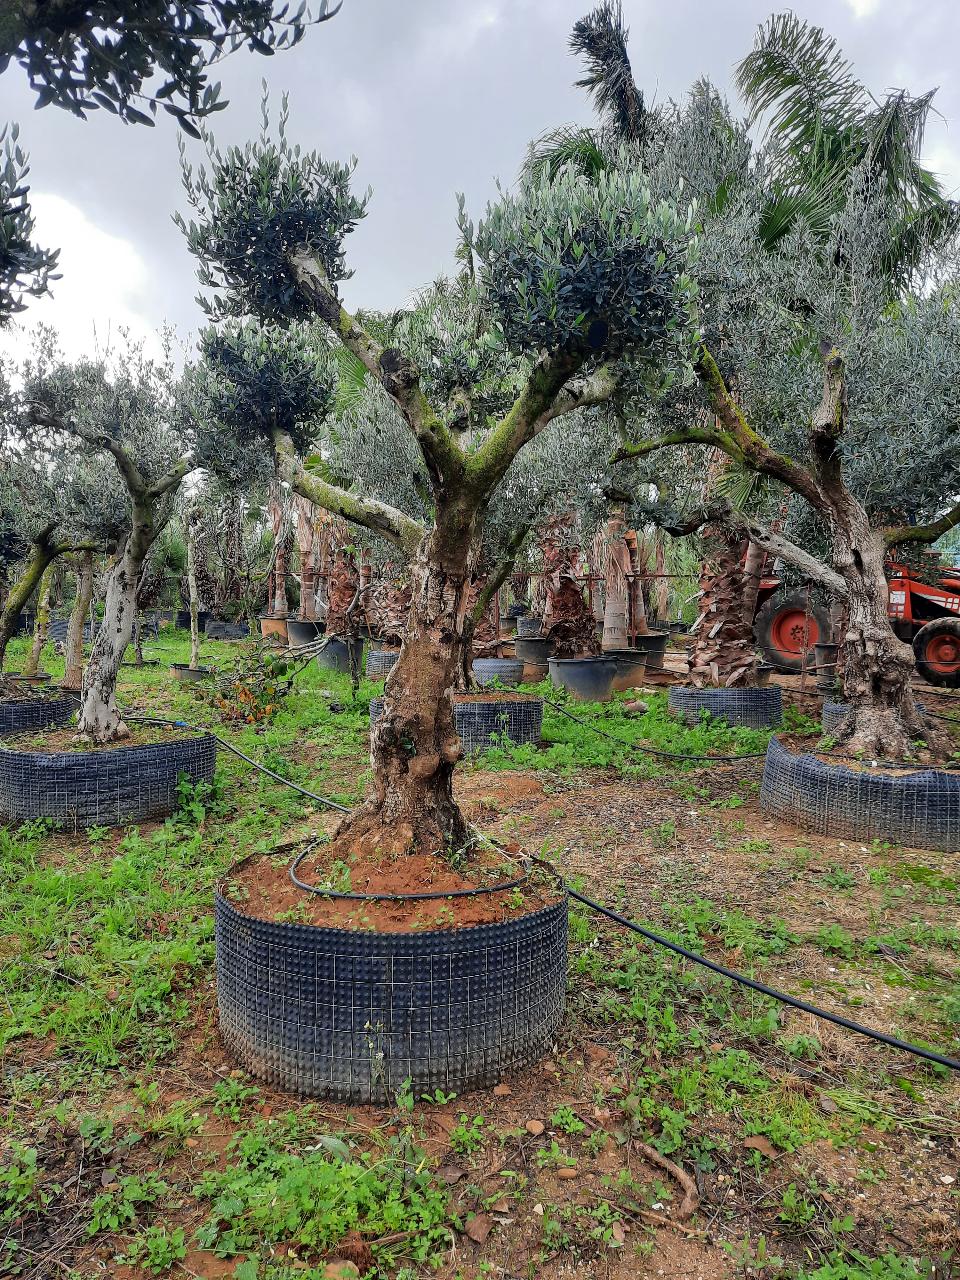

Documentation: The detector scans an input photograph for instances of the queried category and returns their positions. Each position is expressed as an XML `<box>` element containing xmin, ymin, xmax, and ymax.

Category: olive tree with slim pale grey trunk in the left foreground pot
<box><xmin>23</xmin><ymin>346</ymin><xmax>193</xmax><ymax>744</ymax></box>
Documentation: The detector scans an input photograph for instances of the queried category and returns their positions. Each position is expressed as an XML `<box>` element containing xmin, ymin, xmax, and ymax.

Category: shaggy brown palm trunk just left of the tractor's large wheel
<box><xmin>690</xmin><ymin>525</ymin><xmax>759</xmax><ymax>689</ymax></box>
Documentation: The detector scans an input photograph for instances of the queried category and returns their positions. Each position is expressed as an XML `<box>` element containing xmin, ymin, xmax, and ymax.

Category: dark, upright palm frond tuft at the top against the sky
<box><xmin>570</xmin><ymin>0</ymin><xmax>646</xmax><ymax>143</ymax></box>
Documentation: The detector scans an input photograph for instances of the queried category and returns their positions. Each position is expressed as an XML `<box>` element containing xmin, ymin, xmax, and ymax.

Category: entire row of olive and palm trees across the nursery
<box><xmin>5</xmin><ymin>4</ymin><xmax>960</xmax><ymax>850</ymax></box>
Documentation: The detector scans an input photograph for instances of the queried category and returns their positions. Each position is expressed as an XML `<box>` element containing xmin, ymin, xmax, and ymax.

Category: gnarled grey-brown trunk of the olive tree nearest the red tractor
<box><xmin>832</xmin><ymin>514</ymin><xmax>940</xmax><ymax>760</ymax></box>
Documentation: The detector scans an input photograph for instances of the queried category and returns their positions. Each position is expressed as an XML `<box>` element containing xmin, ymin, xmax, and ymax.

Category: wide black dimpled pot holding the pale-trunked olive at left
<box><xmin>0</xmin><ymin>737</ymin><xmax>216</xmax><ymax>829</ymax></box>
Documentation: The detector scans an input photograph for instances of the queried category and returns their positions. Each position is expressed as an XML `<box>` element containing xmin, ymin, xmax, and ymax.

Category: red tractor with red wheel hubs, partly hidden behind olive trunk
<box><xmin>754</xmin><ymin>552</ymin><xmax>960</xmax><ymax>689</ymax></box>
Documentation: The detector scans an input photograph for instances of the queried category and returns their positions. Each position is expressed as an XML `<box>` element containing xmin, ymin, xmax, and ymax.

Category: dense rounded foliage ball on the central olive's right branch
<box><xmin>462</xmin><ymin>164</ymin><xmax>694</xmax><ymax>358</ymax></box>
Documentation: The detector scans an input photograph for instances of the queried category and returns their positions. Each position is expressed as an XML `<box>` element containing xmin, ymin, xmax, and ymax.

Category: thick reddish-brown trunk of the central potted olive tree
<box><xmin>338</xmin><ymin>511</ymin><xmax>472</xmax><ymax>855</ymax></box>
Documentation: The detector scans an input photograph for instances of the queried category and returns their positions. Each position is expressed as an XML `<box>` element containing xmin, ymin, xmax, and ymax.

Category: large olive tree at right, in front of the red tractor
<box><xmin>620</xmin><ymin>172</ymin><xmax>960</xmax><ymax>756</ymax></box>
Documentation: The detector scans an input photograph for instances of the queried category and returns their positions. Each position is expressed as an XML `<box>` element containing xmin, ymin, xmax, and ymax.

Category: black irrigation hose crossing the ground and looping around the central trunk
<box><xmin>128</xmin><ymin>703</ymin><xmax>960</xmax><ymax>1071</ymax></box>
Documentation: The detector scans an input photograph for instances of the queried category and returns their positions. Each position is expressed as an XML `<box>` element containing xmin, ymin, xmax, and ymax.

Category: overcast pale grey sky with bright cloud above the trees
<box><xmin>0</xmin><ymin>0</ymin><xmax>960</xmax><ymax>355</ymax></box>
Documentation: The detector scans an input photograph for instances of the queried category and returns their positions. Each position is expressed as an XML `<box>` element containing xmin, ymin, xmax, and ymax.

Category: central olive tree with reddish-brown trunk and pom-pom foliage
<box><xmin>184</xmin><ymin>112</ymin><xmax>691</xmax><ymax>851</ymax></box>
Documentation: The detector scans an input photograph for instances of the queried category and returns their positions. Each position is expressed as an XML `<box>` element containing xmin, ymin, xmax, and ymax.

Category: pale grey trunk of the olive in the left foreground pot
<box><xmin>77</xmin><ymin>499</ymin><xmax>159</xmax><ymax>745</ymax></box>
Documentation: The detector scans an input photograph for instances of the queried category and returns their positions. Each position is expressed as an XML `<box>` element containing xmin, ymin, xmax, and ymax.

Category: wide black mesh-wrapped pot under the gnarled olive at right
<box><xmin>760</xmin><ymin>737</ymin><xmax>960</xmax><ymax>852</ymax></box>
